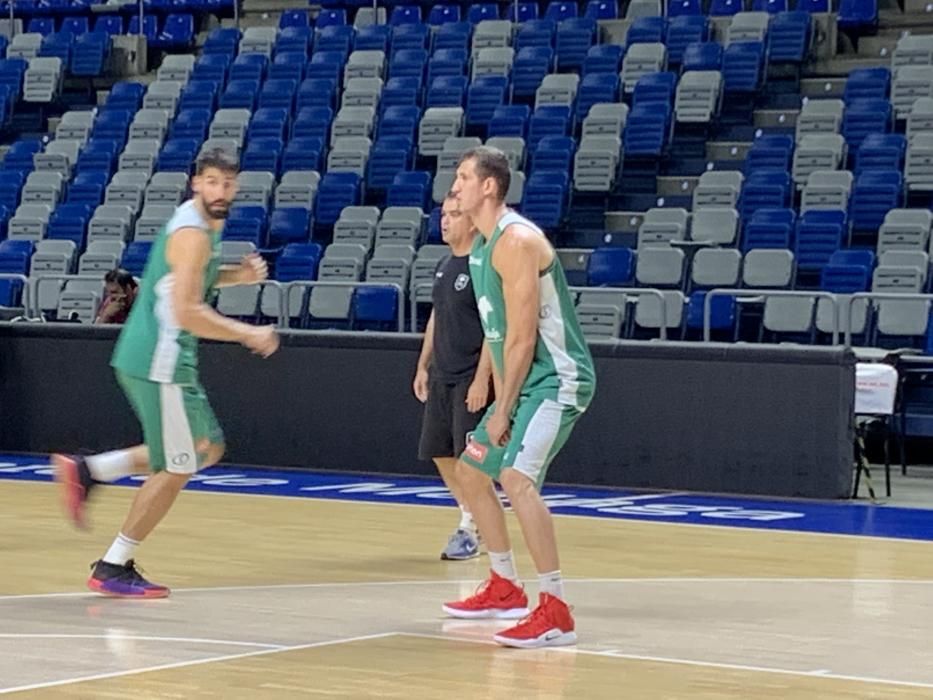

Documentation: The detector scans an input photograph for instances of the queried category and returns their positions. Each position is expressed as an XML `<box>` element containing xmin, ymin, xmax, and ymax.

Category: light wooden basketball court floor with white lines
<box><xmin>0</xmin><ymin>481</ymin><xmax>933</xmax><ymax>700</ymax></box>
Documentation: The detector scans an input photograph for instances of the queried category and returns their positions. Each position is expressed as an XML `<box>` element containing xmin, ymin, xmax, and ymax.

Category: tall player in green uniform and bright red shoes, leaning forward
<box><xmin>444</xmin><ymin>147</ymin><xmax>596</xmax><ymax>648</ymax></box>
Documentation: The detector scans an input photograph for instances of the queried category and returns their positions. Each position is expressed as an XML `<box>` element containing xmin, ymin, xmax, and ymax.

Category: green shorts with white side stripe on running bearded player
<box><xmin>117</xmin><ymin>370</ymin><xmax>224</xmax><ymax>474</ymax></box>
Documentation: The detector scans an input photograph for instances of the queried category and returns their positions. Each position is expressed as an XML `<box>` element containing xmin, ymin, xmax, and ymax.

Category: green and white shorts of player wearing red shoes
<box><xmin>460</xmin><ymin>396</ymin><xmax>583</xmax><ymax>489</ymax></box>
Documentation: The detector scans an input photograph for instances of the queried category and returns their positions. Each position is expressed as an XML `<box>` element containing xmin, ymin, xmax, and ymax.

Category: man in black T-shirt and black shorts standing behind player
<box><xmin>414</xmin><ymin>195</ymin><xmax>492</xmax><ymax>560</ymax></box>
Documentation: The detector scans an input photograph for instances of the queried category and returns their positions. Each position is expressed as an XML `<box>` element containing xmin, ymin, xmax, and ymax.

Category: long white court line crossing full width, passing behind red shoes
<box><xmin>0</xmin><ymin>576</ymin><xmax>933</xmax><ymax>604</ymax></box>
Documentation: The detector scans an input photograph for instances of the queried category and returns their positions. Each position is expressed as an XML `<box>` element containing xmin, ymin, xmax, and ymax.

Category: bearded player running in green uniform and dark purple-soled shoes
<box><xmin>52</xmin><ymin>149</ymin><xmax>279</xmax><ymax>598</ymax></box>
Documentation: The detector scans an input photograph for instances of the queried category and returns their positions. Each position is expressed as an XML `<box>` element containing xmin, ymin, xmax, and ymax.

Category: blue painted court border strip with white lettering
<box><xmin>0</xmin><ymin>455</ymin><xmax>933</xmax><ymax>541</ymax></box>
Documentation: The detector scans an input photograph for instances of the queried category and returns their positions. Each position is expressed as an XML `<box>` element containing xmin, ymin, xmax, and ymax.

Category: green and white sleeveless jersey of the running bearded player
<box><xmin>110</xmin><ymin>200</ymin><xmax>220</xmax><ymax>384</ymax></box>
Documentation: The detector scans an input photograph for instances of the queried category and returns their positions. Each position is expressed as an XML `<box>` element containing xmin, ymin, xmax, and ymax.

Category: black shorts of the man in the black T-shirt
<box><xmin>418</xmin><ymin>377</ymin><xmax>486</xmax><ymax>460</ymax></box>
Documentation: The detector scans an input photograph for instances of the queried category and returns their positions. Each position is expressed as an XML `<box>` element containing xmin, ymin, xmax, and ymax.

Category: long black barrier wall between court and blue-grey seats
<box><xmin>0</xmin><ymin>324</ymin><xmax>855</xmax><ymax>498</ymax></box>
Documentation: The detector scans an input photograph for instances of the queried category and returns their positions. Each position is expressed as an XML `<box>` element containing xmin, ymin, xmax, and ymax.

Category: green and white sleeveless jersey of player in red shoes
<box><xmin>470</xmin><ymin>211</ymin><xmax>596</xmax><ymax>410</ymax></box>
